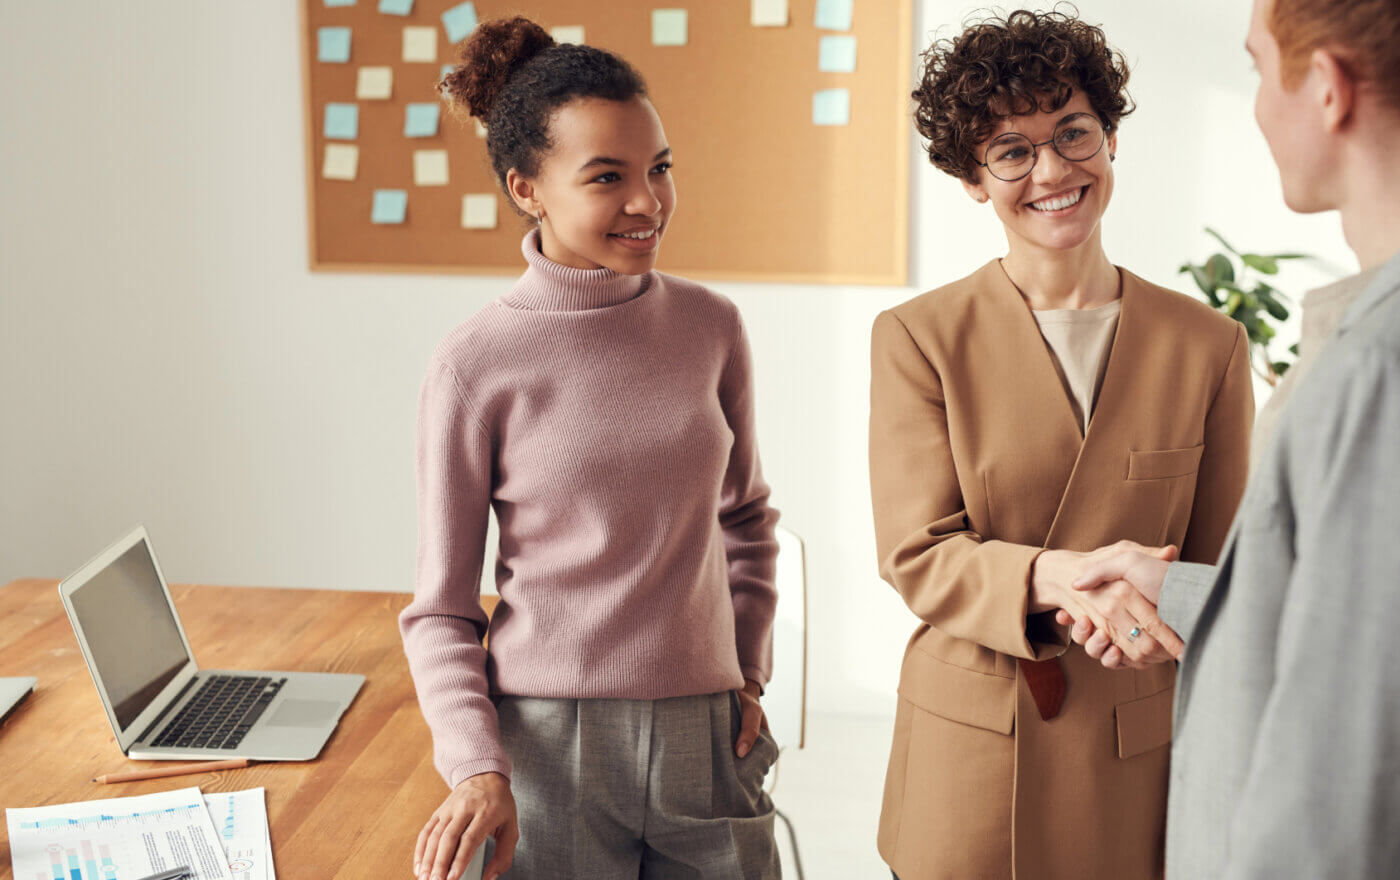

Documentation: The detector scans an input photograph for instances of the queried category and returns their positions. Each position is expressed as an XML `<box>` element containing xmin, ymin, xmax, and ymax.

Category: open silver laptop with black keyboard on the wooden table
<box><xmin>59</xmin><ymin>526</ymin><xmax>364</xmax><ymax>761</ymax></box>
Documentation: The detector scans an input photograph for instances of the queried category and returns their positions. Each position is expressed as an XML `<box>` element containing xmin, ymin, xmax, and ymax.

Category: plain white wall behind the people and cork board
<box><xmin>0</xmin><ymin>0</ymin><xmax>1354</xmax><ymax>712</ymax></box>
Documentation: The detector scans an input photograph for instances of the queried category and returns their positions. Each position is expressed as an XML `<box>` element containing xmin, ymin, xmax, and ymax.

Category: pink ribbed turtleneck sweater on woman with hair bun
<box><xmin>399</xmin><ymin>232</ymin><xmax>777</xmax><ymax>786</ymax></box>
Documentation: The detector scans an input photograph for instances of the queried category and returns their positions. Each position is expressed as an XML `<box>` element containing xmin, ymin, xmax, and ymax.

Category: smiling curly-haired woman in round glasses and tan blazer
<box><xmin>869</xmin><ymin>11</ymin><xmax>1253</xmax><ymax>880</ymax></box>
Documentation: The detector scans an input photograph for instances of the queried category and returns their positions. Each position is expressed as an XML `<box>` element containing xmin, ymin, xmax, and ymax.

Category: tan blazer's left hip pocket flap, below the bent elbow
<box><xmin>899</xmin><ymin>646</ymin><xmax>1016</xmax><ymax>734</ymax></box>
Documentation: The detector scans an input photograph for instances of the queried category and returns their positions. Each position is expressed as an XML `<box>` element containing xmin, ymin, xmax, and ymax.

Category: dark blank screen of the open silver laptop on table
<box><xmin>70</xmin><ymin>540</ymin><xmax>193</xmax><ymax>732</ymax></box>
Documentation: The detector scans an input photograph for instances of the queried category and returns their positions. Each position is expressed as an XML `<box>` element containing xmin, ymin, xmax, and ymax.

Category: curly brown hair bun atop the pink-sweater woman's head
<box><xmin>438</xmin><ymin>15</ymin><xmax>554</xmax><ymax>122</ymax></box>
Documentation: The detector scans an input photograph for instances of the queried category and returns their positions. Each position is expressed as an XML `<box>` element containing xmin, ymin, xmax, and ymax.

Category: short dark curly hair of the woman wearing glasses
<box><xmin>913</xmin><ymin>7</ymin><xmax>1134</xmax><ymax>183</ymax></box>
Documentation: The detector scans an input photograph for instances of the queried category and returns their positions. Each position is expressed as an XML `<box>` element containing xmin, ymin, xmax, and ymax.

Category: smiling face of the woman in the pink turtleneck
<box><xmin>507</xmin><ymin>98</ymin><xmax>676</xmax><ymax>276</ymax></box>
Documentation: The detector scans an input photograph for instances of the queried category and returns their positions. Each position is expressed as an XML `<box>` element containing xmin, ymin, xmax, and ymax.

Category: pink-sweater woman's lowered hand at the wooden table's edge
<box><xmin>413</xmin><ymin>774</ymin><xmax>521</xmax><ymax>880</ymax></box>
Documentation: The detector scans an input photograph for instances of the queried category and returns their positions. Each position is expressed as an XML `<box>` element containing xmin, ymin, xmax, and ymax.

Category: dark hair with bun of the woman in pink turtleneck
<box><xmin>438</xmin><ymin>15</ymin><xmax>647</xmax><ymax>204</ymax></box>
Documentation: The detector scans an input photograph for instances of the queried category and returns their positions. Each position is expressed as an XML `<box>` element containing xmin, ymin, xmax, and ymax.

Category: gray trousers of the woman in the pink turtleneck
<box><xmin>496</xmin><ymin>691</ymin><xmax>781</xmax><ymax>880</ymax></box>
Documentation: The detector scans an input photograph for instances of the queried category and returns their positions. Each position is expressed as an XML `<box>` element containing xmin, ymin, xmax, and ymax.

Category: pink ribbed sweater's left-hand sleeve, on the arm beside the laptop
<box><xmin>399</xmin><ymin>360</ymin><xmax>510</xmax><ymax>788</ymax></box>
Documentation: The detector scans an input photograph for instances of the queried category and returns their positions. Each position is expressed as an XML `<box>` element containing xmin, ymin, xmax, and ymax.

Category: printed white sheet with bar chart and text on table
<box><xmin>6</xmin><ymin>788</ymin><xmax>232</xmax><ymax>880</ymax></box>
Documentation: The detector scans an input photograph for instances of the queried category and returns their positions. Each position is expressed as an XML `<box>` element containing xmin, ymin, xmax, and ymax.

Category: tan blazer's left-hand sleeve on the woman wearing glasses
<box><xmin>869</xmin><ymin>312</ymin><xmax>1065</xmax><ymax>660</ymax></box>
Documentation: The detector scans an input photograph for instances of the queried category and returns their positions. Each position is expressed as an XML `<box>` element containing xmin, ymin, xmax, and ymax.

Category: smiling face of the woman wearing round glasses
<box><xmin>963</xmin><ymin>90</ymin><xmax>1117</xmax><ymax>250</ymax></box>
